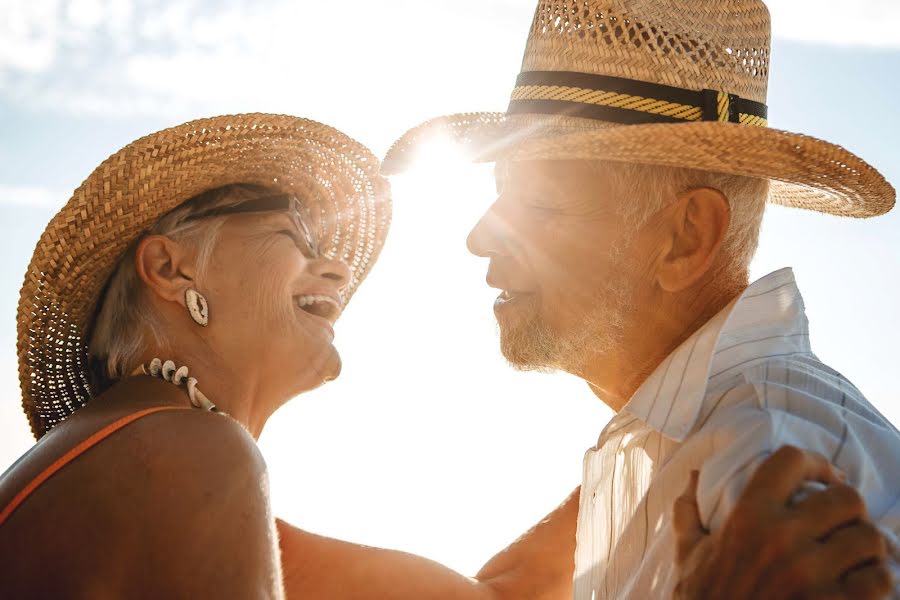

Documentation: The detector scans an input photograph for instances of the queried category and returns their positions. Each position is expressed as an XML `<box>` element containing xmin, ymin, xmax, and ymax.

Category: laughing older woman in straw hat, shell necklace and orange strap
<box><xmin>0</xmin><ymin>114</ymin><xmax>884</xmax><ymax>600</ymax></box>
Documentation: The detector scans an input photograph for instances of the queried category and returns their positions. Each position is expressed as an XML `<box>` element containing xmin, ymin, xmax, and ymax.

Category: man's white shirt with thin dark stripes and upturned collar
<box><xmin>574</xmin><ymin>269</ymin><xmax>900</xmax><ymax>600</ymax></box>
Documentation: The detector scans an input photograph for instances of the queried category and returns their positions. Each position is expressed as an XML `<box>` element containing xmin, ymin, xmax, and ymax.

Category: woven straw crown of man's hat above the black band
<box><xmin>522</xmin><ymin>0</ymin><xmax>771</xmax><ymax>104</ymax></box>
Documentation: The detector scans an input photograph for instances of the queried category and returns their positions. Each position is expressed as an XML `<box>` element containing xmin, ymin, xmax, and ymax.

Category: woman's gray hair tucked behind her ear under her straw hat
<box><xmin>88</xmin><ymin>184</ymin><xmax>275</xmax><ymax>384</ymax></box>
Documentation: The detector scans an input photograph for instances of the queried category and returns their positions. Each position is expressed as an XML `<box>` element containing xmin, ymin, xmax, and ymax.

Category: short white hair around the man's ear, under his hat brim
<box><xmin>592</xmin><ymin>161</ymin><xmax>769</xmax><ymax>283</ymax></box>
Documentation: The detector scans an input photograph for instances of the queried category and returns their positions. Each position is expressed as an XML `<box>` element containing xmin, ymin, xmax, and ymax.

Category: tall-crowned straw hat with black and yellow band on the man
<box><xmin>382</xmin><ymin>0</ymin><xmax>895</xmax><ymax>217</ymax></box>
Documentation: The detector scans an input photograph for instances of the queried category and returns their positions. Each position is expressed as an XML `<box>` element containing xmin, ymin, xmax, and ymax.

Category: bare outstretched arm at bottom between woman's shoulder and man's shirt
<box><xmin>277</xmin><ymin>490</ymin><xmax>579</xmax><ymax>600</ymax></box>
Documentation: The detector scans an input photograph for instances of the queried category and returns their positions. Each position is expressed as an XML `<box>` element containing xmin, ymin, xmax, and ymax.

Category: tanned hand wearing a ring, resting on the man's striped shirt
<box><xmin>674</xmin><ymin>446</ymin><xmax>893</xmax><ymax>600</ymax></box>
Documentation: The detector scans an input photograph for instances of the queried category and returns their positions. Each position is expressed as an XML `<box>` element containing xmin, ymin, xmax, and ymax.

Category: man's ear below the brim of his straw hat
<box><xmin>657</xmin><ymin>187</ymin><xmax>731</xmax><ymax>292</ymax></box>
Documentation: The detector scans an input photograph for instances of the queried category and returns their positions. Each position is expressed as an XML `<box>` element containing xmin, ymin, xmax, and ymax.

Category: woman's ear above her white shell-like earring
<box><xmin>134</xmin><ymin>235</ymin><xmax>196</xmax><ymax>306</ymax></box>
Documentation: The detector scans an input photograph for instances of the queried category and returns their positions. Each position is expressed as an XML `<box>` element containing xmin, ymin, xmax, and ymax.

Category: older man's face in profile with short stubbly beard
<box><xmin>468</xmin><ymin>161</ymin><xmax>645</xmax><ymax>374</ymax></box>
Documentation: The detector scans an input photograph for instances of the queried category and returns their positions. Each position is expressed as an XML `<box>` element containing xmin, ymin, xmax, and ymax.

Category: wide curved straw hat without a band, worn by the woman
<box><xmin>17</xmin><ymin>114</ymin><xmax>391</xmax><ymax>438</ymax></box>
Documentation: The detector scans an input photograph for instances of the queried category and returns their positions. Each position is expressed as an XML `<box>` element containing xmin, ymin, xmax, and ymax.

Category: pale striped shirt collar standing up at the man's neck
<box><xmin>620</xmin><ymin>269</ymin><xmax>810</xmax><ymax>442</ymax></box>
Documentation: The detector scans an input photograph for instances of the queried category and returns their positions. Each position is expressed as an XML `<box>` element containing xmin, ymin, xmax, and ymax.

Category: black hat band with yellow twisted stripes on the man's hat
<box><xmin>507</xmin><ymin>71</ymin><xmax>769</xmax><ymax>127</ymax></box>
